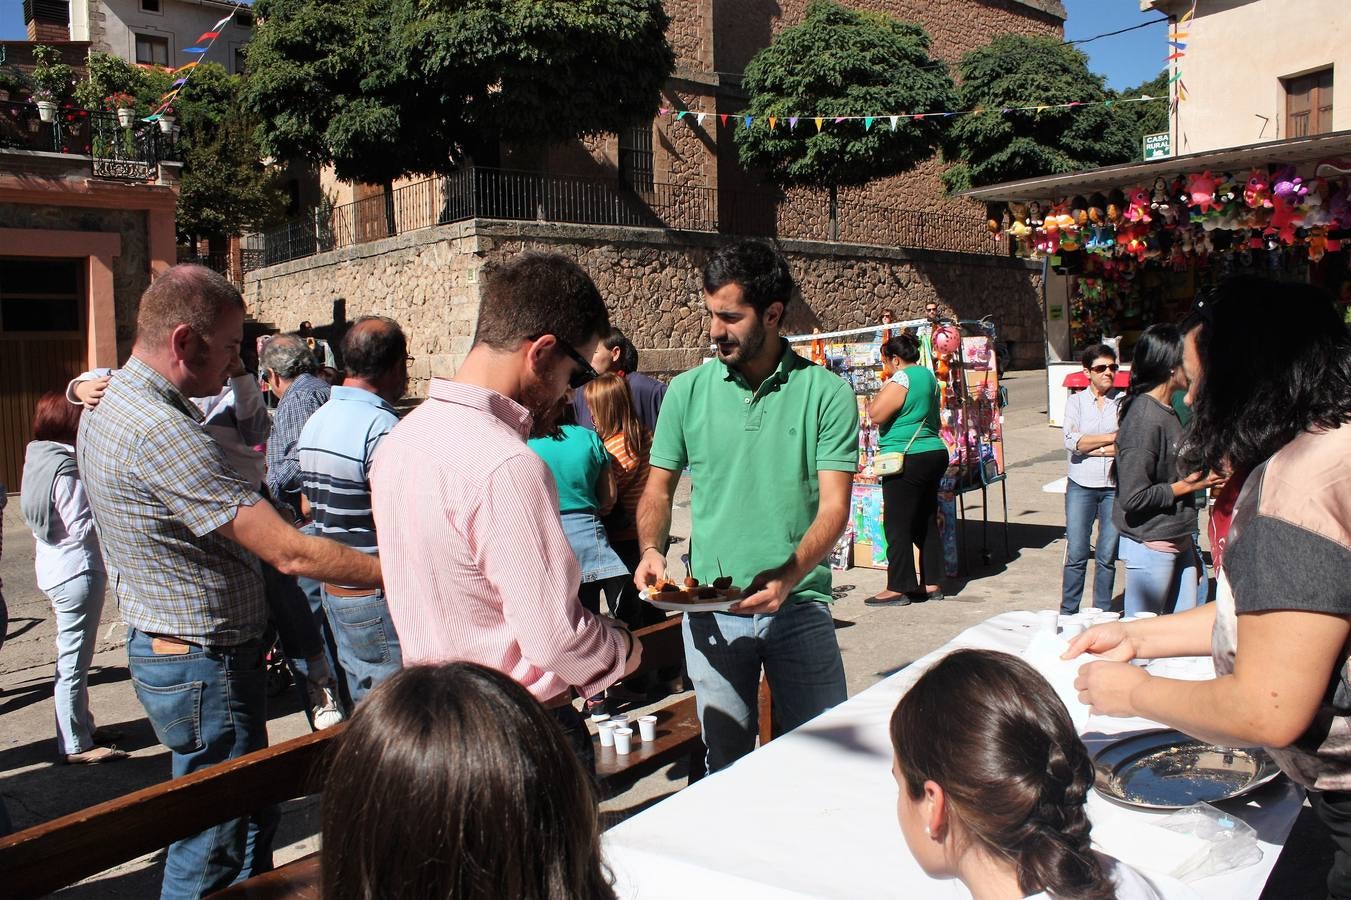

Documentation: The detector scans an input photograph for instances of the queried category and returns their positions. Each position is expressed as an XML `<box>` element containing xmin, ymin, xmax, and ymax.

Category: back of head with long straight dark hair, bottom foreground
<box><xmin>320</xmin><ymin>662</ymin><xmax>615</xmax><ymax>900</ymax></box>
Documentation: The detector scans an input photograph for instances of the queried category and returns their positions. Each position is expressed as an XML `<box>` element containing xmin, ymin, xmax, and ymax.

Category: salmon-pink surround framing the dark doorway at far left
<box><xmin>0</xmin><ymin>203</ymin><xmax>150</xmax><ymax>359</ymax></box>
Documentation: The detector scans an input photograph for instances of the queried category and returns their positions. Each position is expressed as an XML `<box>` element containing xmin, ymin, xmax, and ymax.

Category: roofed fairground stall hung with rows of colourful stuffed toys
<box><xmin>965</xmin><ymin>131</ymin><xmax>1351</xmax><ymax>424</ymax></box>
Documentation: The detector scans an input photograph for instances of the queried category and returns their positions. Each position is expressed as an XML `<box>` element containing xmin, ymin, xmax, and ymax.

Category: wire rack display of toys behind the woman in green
<box><xmin>788</xmin><ymin>319</ymin><xmax>1008</xmax><ymax>576</ymax></box>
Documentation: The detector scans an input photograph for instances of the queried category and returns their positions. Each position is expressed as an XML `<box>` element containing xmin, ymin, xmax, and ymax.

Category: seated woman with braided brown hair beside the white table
<box><xmin>892</xmin><ymin>650</ymin><xmax>1159</xmax><ymax>900</ymax></box>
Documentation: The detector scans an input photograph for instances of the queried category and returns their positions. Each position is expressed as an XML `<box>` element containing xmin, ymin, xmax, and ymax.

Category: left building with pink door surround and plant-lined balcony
<box><xmin>0</xmin><ymin>117</ymin><xmax>181</xmax><ymax>491</ymax></box>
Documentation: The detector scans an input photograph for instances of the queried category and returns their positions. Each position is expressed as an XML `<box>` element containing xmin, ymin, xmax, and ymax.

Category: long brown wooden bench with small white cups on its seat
<box><xmin>0</xmin><ymin>616</ymin><xmax>767</xmax><ymax>899</ymax></box>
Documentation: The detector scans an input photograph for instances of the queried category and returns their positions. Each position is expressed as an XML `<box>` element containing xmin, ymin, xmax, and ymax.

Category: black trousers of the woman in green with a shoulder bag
<box><xmin>882</xmin><ymin>450</ymin><xmax>948</xmax><ymax>593</ymax></box>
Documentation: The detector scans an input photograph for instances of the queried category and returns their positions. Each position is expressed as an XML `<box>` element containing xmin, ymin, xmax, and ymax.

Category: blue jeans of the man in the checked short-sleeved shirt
<box><xmin>127</xmin><ymin>628</ymin><xmax>278</xmax><ymax>899</ymax></box>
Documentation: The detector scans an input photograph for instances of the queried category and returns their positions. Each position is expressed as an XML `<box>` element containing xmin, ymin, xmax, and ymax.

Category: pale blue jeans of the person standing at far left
<box><xmin>46</xmin><ymin>572</ymin><xmax>108</xmax><ymax>754</ymax></box>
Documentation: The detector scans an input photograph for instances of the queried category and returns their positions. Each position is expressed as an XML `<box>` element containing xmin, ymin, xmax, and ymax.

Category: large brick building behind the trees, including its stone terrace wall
<box><xmin>245</xmin><ymin>0</ymin><xmax>1065</xmax><ymax>393</ymax></box>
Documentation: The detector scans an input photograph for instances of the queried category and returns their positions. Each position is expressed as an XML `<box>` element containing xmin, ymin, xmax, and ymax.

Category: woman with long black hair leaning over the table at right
<box><xmin>1066</xmin><ymin>278</ymin><xmax>1351</xmax><ymax>900</ymax></box>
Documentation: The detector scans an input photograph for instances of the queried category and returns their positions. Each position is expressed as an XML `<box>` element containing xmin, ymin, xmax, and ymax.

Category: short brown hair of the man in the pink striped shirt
<box><xmin>474</xmin><ymin>253</ymin><xmax>609</xmax><ymax>350</ymax></box>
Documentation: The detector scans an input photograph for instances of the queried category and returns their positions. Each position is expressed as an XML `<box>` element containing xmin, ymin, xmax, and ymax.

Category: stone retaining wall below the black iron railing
<box><xmin>245</xmin><ymin>220</ymin><xmax>1044</xmax><ymax>395</ymax></box>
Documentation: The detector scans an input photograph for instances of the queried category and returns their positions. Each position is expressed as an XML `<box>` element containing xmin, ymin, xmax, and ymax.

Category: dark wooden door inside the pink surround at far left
<box><xmin>0</xmin><ymin>257</ymin><xmax>88</xmax><ymax>491</ymax></box>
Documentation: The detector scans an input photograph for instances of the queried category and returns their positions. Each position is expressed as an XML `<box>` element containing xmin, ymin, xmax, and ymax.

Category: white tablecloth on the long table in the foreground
<box><xmin>604</xmin><ymin>612</ymin><xmax>1304</xmax><ymax>900</ymax></box>
